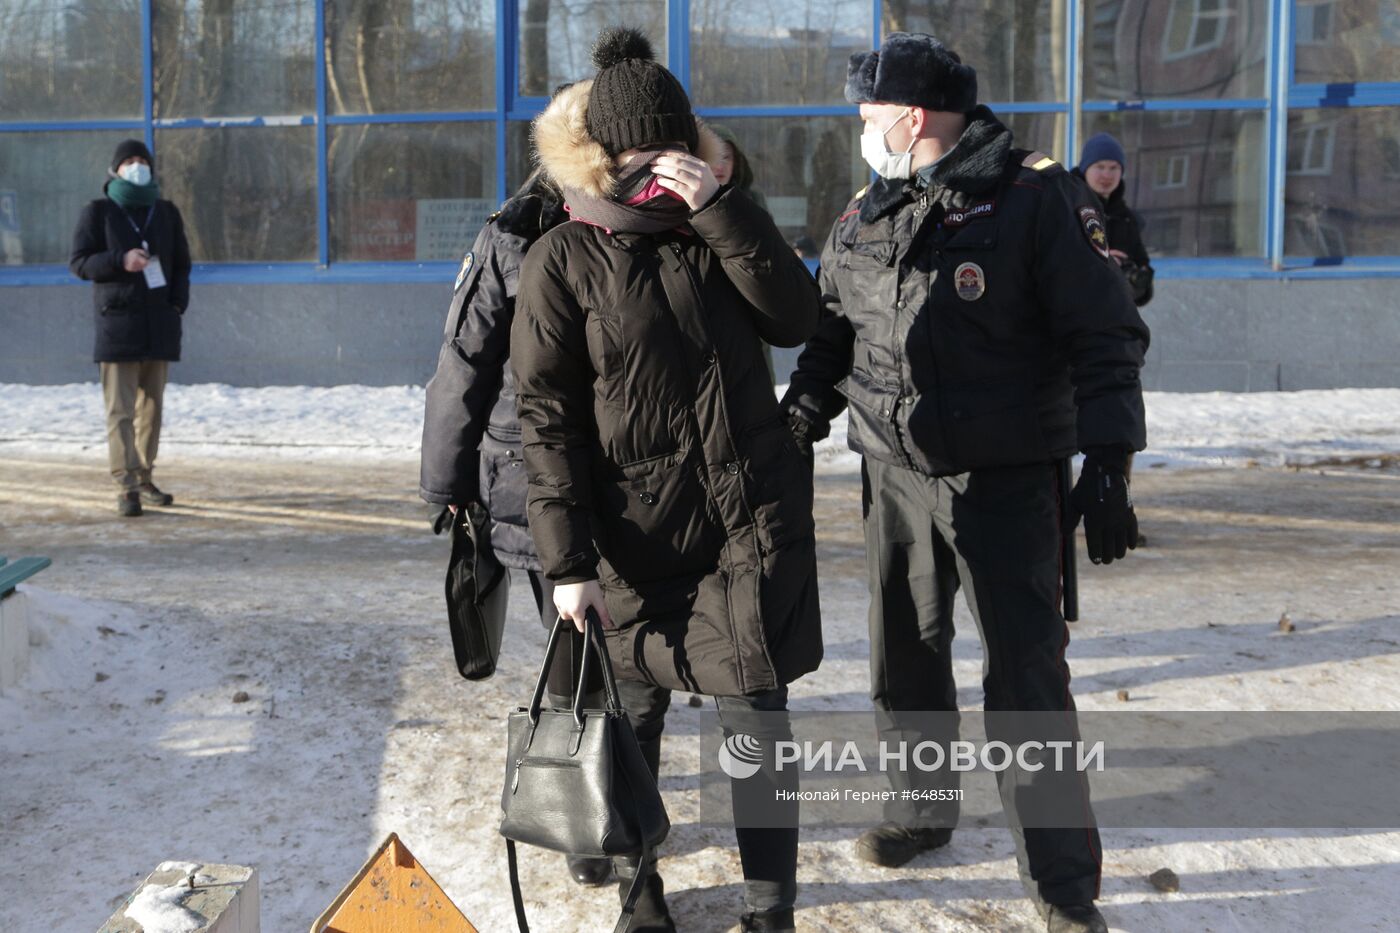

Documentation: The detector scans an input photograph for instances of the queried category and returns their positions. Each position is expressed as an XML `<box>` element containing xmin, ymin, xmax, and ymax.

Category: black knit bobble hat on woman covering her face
<box><xmin>584</xmin><ymin>27</ymin><xmax>700</xmax><ymax>156</ymax></box>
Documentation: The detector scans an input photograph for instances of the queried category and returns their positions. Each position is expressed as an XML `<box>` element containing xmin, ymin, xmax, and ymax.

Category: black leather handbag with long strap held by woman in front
<box><xmin>501</xmin><ymin>611</ymin><xmax>671</xmax><ymax>933</ymax></box>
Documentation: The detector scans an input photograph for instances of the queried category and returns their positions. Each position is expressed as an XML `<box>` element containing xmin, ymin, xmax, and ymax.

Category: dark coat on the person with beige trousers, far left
<box><xmin>69</xmin><ymin>187</ymin><xmax>190</xmax><ymax>363</ymax></box>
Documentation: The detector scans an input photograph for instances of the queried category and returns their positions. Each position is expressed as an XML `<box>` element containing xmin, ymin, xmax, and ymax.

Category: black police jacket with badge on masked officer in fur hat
<box><xmin>784</xmin><ymin>106</ymin><xmax>1148</xmax><ymax>476</ymax></box>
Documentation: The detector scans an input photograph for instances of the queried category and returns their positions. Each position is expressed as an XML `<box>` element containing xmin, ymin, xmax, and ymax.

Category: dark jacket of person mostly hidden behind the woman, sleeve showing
<box><xmin>419</xmin><ymin>178</ymin><xmax>564</xmax><ymax>570</ymax></box>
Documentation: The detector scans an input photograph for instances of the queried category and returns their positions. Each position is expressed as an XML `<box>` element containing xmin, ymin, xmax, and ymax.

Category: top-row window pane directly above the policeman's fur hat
<box><xmin>882</xmin><ymin>0</ymin><xmax>1068</xmax><ymax>102</ymax></box>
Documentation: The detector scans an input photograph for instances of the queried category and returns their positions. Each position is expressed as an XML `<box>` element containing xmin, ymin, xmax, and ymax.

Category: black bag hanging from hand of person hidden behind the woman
<box><xmin>447</xmin><ymin>503</ymin><xmax>511</xmax><ymax>681</ymax></box>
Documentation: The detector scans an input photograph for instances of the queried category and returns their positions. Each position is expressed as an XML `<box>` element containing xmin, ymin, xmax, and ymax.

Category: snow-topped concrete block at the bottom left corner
<box><xmin>98</xmin><ymin>862</ymin><xmax>260</xmax><ymax>933</ymax></box>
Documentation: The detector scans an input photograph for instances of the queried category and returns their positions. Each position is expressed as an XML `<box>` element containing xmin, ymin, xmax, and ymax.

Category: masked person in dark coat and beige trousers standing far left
<box><xmin>69</xmin><ymin>139</ymin><xmax>190</xmax><ymax>517</ymax></box>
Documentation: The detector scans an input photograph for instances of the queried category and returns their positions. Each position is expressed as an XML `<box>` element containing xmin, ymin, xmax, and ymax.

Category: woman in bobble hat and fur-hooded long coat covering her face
<box><xmin>511</xmin><ymin>29</ymin><xmax>822</xmax><ymax>932</ymax></box>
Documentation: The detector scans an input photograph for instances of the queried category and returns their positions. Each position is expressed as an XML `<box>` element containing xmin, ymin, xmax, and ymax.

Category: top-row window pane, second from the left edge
<box><xmin>151</xmin><ymin>0</ymin><xmax>316</xmax><ymax>118</ymax></box>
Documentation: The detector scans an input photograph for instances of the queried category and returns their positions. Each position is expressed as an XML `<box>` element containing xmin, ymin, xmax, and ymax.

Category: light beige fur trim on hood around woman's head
<box><xmin>533</xmin><ymin>78</ymin><xmax>724</xmax><ymax>198</ymax></box>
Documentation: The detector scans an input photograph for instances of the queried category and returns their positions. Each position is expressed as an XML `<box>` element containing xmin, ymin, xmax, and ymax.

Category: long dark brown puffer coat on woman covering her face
<box><xmin>511</xmin><ymin>81</ymin><xmax>822</xmax><ymax>696</ymax></box>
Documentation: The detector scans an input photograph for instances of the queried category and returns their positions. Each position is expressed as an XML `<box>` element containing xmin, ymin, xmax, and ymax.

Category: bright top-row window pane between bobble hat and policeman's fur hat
<box><xmin>690</xmin><ymin>0</ymin><xmax>874</xmax><ymax>106</ymax></box>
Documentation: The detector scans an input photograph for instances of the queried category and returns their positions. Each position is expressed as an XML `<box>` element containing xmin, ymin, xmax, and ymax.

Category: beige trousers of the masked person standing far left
<box><xmin>98</xmin><ymin>360</ymin><xmax>169</xmax><ymax>489</ymax></box>
